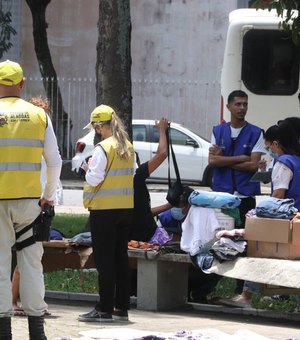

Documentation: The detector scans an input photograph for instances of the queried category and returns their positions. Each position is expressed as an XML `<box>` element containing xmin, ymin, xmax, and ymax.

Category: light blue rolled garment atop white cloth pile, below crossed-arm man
<box><xmin>188</xmin><ymin>191</ymin><xmax>241</xmax><ymax>209</ymax></box>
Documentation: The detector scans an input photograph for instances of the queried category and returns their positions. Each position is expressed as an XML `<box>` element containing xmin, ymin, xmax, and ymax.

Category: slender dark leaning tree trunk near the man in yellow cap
<box><xmin>26</xmin><ymin>0</ymin><xmax>72</xmax><ymax>155</ymax></box>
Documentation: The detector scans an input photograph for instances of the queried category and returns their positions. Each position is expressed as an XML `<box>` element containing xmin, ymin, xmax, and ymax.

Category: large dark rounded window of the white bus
<box><xmin>242</xmin><ymin>29</ymin><xmax>299</xmax><ymax>95</ymax></box>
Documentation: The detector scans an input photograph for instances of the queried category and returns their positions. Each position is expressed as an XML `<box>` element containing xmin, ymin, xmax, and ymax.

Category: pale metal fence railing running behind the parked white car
<box><xmin>23</xmin><ymin>77</ymin><xmax>220</xmax><ymax>160</ymax></box>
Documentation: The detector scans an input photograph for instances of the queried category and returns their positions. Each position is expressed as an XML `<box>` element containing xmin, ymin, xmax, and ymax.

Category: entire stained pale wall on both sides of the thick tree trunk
<box><xmin>4</xmin><ymin>0</ymin><xmax>240</xmax><ymax>154</ymax></box>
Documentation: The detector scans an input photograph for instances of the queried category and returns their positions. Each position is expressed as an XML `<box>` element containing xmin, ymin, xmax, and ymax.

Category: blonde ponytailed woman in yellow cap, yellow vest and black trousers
<box><xmin>78</xmin><ymin>105</ymin><xmax>135</xmax><ymax>322</ymax></box>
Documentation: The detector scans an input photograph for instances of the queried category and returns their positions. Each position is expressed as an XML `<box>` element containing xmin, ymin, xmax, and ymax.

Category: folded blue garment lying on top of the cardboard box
<box><xmin>255</xmin><ymin>197</ymin><xmax>298</xmax><ymax>219</ymax></box>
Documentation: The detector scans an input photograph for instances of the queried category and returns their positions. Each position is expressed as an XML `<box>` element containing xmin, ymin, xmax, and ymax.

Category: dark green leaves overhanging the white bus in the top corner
<box><xmin>252</xmin><ymin>0</ymin><xmax>300</xmax><ymax>46</ymax></box>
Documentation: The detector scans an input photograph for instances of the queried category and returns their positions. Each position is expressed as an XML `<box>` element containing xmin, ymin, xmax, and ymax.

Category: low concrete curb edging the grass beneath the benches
<box><xmin>45</xmin><ymin>291</ymin><xmax>300</xmax><ymax>322</ymax></box>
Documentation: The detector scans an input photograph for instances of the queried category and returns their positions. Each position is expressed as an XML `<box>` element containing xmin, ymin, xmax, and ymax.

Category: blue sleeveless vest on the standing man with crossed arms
<box><xmin>213</xmin><ymin>123</ymin><xmax>261</xmax><ymax>196</ymax></box>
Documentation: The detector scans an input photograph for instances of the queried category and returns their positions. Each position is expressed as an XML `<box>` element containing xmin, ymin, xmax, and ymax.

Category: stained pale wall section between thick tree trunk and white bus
<box><xmin>131</xmin><ymin>0</ymin><xmax>236</xmax><ymax>138</ymax></box>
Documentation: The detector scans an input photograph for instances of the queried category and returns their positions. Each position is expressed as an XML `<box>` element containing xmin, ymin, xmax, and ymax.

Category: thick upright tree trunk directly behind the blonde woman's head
<box><xmin>96</xmin><ymin>0</ymin><xmax>132</xmax><ymax>137</ymax></box>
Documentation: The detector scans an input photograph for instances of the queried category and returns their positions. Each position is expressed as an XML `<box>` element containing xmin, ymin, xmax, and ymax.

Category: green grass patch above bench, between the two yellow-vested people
<box><xmin>52</xmin><ymin>214</ymin><xmax>88</xmax><ymax>238</ymax></box>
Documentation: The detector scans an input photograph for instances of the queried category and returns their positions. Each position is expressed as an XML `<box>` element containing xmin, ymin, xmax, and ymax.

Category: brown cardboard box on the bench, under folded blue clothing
<box><xmin>245</xmin><ymin>217</ymin><xmax>300</xmax><ymax>260</ymax></box>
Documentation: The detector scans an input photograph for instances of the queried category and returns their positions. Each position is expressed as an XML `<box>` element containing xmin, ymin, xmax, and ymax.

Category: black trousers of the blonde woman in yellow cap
<box><xmin>90</xmin><ymin>209</ymin><xmax>133</xmax><ymax>314</ymax></box>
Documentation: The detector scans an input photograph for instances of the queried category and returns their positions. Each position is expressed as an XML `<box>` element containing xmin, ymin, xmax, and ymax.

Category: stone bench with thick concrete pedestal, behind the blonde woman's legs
<box><xmin>42</xmin><ymin>241</ymin><xmax>191</xmax><ymax>310</ymax></box>
